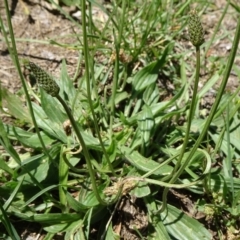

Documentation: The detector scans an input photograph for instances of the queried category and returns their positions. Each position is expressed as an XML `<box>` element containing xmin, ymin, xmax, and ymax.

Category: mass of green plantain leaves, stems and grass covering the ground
<box><xmin>0</xmin><ymin>0</ymin><xmax>240</xmax><ymax>239</ymax></box>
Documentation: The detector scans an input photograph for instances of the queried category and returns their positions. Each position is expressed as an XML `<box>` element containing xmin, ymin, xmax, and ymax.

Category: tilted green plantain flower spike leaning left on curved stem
<box><xmin>23</xmin><ymin>59</ymin><xmax>60</xmax><ymax>97</ymax></box>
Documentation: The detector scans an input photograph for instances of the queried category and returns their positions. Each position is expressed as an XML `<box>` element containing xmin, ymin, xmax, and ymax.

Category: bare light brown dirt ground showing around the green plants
<box><xmin>0</xmin><ymin>0</ymin><xmax>240</xmax><ymax>240</ymax></box>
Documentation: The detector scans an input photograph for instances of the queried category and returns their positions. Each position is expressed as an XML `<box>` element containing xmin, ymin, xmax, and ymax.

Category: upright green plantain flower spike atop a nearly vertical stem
<box><xmin>188</xmin><ymin>10</ymin><xmax>204</xmax><ymax>47</ymax></box>
